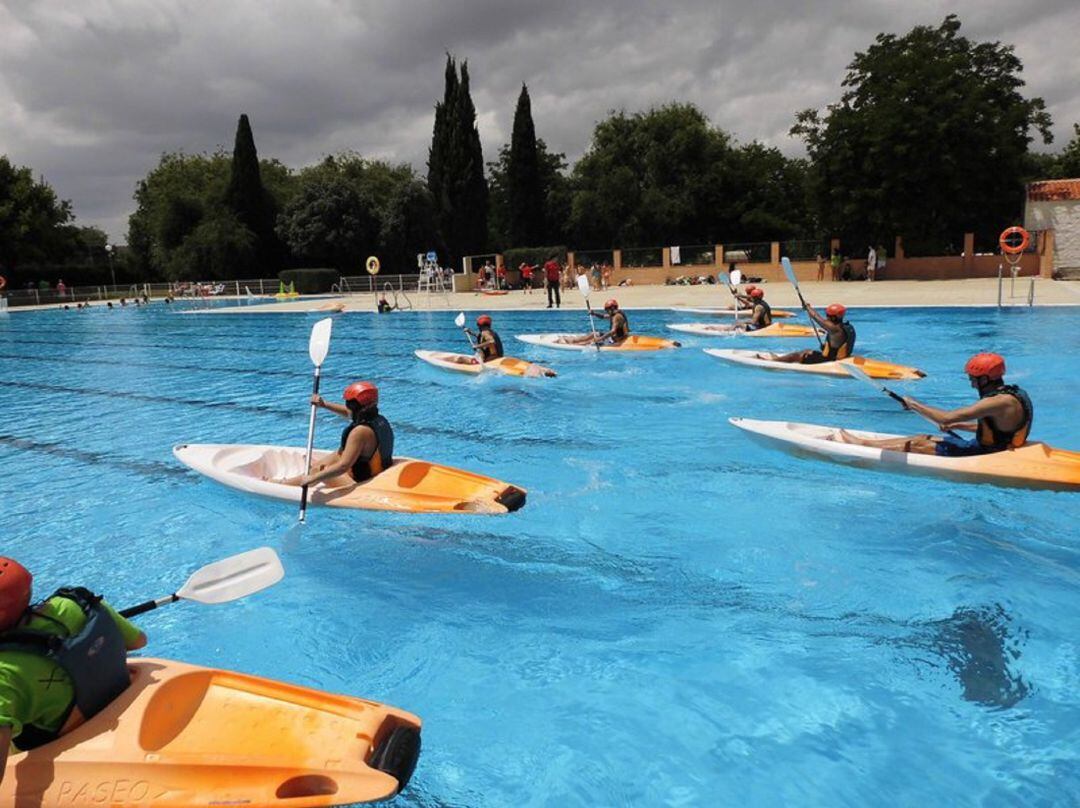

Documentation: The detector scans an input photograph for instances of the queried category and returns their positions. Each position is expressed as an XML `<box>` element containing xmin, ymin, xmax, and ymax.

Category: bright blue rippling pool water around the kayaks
<box><xmin>0</xmin><ymin>305</ymin><xmax>1080</xmax><ymax>806</ymax></box>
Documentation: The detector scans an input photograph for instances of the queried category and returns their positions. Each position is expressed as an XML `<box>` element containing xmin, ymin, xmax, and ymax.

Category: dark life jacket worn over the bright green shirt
<box><xmin>0</xmin><ymin>587</ymin><xmax>131</xmax><ymax>750</ymax></box>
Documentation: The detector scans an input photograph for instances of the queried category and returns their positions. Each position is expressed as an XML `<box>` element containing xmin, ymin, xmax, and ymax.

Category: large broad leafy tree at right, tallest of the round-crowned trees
<box><xmin>792</xmin><ymin>15</ymin><xmax>1051</xmax><ymax>250</ymax></box>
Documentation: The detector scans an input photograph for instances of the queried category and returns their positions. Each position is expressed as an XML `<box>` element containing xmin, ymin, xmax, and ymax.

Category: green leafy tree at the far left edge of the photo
<box><xmin>0</xmin><ymin>156</ymin><xmax>73</xmax><ymax>271</ymax></box>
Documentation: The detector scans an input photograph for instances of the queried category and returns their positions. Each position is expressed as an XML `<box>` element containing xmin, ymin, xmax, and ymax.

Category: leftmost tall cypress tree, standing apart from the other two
<box><xmin>225</xmin><ymin>115</ymin><xmax>283</xmax><ymax>274</ymax></box>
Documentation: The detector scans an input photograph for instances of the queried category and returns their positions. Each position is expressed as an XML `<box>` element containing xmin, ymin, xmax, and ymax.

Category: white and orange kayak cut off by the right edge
<box><xmin>728</xmin><ymin>418</ymin><xmax>1080</xmax><ymax>491</ymax></box>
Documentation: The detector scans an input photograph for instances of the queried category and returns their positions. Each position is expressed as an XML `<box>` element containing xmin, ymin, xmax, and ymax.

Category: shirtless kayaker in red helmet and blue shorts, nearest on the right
<box><xmin>838</xmin><ymin>353</ymin><xmax>1035</xmax><ymax>457</ymax></box>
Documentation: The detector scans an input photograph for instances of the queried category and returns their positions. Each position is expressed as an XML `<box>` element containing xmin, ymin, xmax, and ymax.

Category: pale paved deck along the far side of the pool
<box><xmin>9</xmin><ymin>278</ymin><xmax>1080</xmax><ymax>314</ymax></box>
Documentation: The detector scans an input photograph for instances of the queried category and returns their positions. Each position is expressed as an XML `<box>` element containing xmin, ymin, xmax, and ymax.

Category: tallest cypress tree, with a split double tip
<box><xmin>428</xmin><ymin>54</ymin><xmax>488</xmax><ymax>271</ymax></box>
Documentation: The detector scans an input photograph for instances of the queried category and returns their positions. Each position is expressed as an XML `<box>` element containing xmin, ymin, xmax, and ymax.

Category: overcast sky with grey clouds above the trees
<box><xmin>0</xmin><ymin>0</ymin><xmax>1080</xmax><ymax>243</ymax></box>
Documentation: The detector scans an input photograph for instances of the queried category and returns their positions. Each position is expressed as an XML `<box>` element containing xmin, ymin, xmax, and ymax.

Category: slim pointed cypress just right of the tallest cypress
<box><xmin>507</xmin><ymin>84</ymin><xmax>544</xmax><ymax>247</ymax></box>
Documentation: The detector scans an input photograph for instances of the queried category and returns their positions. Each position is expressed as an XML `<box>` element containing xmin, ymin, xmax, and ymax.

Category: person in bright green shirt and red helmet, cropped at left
<box><xmin>0</xmin><ymin>557</ymin><xmax>146</xmax><ymax>780</ymax></box>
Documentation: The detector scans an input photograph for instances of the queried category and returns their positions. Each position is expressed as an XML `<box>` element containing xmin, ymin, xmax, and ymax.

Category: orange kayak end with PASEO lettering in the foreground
<box><xmin>0</xmin><ymin>659</ymin><xmax>420</xmax><ymax>808</ymax></box>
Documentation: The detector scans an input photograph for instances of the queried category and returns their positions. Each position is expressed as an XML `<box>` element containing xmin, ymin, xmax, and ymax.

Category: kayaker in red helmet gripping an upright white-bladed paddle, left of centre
<box><xmin>276</xmin><ymin>381</ymin><xmax>394</xmax><ymax>485</ymax></box>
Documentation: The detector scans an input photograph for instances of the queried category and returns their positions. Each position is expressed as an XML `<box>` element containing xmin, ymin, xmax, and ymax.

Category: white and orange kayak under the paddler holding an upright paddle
<box><xmin>173</xmin><ymin>443</ymin><xmax>526</xmax><ymax>514</ymax></box>
